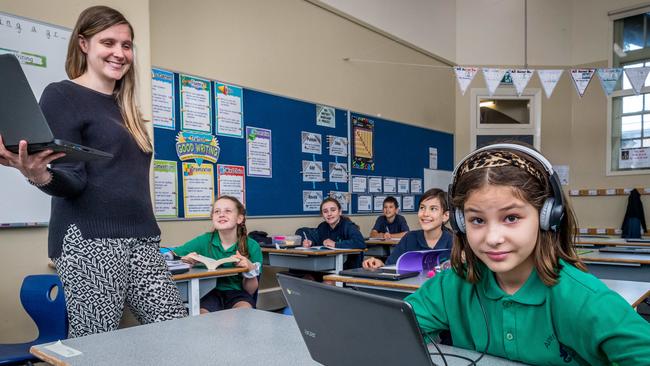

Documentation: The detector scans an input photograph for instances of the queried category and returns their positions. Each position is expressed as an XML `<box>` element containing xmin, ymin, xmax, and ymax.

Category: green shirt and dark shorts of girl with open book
<box><xmin>173</xmin><ymin>233</ymin><xmax>262</xmax><ymax>291</ymax></box>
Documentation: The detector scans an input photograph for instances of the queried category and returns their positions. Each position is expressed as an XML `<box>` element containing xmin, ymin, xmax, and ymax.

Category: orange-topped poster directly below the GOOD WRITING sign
<box><xmin>183</xmin><ymin>163</ymin><xmax>214</xmax><ymax>219</ymax></box>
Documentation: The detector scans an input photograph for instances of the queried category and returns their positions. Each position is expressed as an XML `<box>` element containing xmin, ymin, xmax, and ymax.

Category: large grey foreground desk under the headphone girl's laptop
<box><xmin>30</xmin><ymin>309</ymin><xmax>519</xmax><ymax>366</ymax></box>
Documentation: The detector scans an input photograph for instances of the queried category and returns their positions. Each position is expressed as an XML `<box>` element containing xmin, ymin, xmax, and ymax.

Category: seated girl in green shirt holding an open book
<box><xmin>173</xmin><ymin>196</ymin><xmax>262</xmax><ymax>314</ymax></box>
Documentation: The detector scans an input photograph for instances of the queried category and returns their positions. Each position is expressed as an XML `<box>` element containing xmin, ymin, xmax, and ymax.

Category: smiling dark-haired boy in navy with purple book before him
<box><xmin>363</xmin><ymin>188</ymin><xmax>453</xmax><ymax>268</ymax></box>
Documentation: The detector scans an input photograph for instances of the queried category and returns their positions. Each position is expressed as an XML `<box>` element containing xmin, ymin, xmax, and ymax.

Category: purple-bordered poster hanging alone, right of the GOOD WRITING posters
<box><xmin>246</xmin><ymin>127</ymin><xmax>273</xmax><ymax>178</ymax></box>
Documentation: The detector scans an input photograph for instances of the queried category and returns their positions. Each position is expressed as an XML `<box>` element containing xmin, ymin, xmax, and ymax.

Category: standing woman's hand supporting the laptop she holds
<box><xmin>0</xmin><ymin>136</ymin><xmax>65</xmax><ymax>184</ymax></box>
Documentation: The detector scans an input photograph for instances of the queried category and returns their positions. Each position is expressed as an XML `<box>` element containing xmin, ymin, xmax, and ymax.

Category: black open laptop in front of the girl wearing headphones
<box><xmin>277</xmin><ymin>274</ymin><xmax>433</xmax><ymax>366</ymax></box>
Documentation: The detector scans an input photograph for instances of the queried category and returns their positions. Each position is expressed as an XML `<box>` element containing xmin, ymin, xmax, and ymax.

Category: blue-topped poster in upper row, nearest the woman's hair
<box><xmin>151</xmin><ymin>69</ymin><xmax>176</xmax><ymax>130</ymax></box>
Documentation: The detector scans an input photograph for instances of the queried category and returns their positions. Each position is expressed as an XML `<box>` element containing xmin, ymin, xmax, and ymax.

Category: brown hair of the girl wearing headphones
<box><xmin>451</xmin><ymin>151</ymin><xmax>587</xmax><ymax>286</ymax></box>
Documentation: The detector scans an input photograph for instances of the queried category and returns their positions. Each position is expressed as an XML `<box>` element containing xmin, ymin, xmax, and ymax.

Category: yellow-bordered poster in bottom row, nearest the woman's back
<box><xmin>153</xmin><ymin>160</ymin><xmax>178</xmax><ymax>219</ymax></box>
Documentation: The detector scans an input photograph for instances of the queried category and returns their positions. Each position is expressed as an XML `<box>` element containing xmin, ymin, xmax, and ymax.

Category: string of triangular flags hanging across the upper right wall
<box><xmin>454</xmin><ymin>66</ymin><xmax>650</xmax><ymax>98</ymax></box>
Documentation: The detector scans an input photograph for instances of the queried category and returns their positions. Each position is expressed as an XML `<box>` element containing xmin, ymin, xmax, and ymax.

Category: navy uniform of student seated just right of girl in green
<box><xmin>313</xmin><ymin>217</ymin><xmax>366</xmax><ymax>269</ymax></box>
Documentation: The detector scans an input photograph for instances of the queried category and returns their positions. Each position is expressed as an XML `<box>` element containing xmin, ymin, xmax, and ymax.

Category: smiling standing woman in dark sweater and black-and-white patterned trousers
<box><xmin>0</xmin><ymin>6</ymin><xmax>187</xmax><ymax>337</ymax></box>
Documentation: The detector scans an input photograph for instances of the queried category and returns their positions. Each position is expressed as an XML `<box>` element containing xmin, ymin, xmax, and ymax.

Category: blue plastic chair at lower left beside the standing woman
<box><xmin>0</xmin><ymin>274</ymin><xmax>68</xmax><ymax>365</ymax></box>
